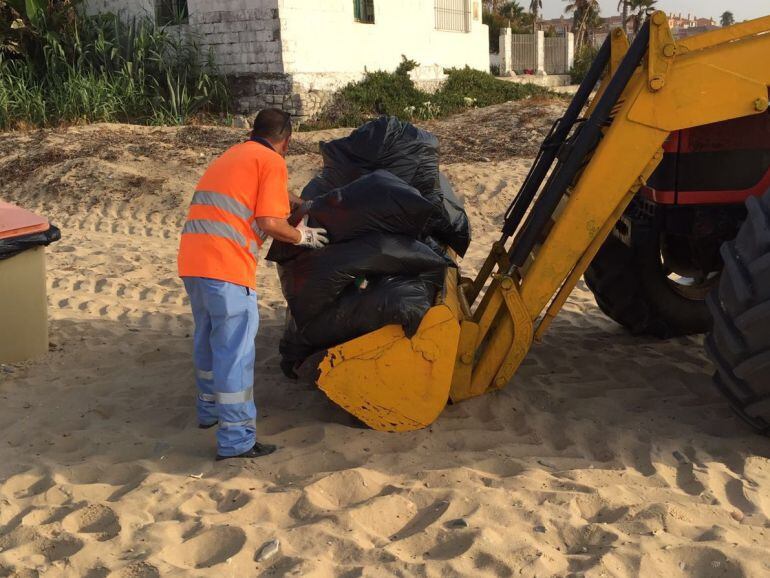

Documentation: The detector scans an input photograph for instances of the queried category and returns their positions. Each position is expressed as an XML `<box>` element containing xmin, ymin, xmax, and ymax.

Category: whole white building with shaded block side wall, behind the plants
<box><xmin>87</xmin><ymin>0</ymin><xmax>489</xmax><ymax>116</ymax></box>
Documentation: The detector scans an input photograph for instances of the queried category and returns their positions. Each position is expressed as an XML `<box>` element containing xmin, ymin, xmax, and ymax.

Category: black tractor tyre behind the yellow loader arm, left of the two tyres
<box><xmin>584</xmin><ymin>228</ymin><xmax>711</xmax><ymax>339</ymax></box>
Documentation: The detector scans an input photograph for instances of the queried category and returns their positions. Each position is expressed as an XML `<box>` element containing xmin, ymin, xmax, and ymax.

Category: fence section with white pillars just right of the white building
<box><xmin>500</xmin><ymin>28</ymin><xmax>575</xmax><ymax>75</ymax></box>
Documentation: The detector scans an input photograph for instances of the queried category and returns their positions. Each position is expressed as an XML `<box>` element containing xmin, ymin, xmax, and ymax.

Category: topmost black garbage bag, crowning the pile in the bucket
<box><xmin>317</xmin><ymin>116</ymin><xmax>439</xmax><ymax>197</ymax></box>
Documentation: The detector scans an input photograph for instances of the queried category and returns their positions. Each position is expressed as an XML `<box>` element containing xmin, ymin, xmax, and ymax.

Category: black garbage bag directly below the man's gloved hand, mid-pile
<box><xmin>279</xmin><ymin>233</ymin><xmax>451</xmax><ymax>330</ymax></box>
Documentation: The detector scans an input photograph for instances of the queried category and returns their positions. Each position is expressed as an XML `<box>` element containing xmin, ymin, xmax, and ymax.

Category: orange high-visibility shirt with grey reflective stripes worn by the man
<box><xmin>178</xmin><ymin>141</ymin><xmax>290</xmax><ymax>289</ymax></box>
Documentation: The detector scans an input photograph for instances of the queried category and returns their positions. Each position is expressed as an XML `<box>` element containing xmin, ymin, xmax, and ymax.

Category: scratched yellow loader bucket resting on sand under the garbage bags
<box><xmin>317</xmin><ymin>269</ymin><xmax>460</xmax><ymax>432</ymax></box>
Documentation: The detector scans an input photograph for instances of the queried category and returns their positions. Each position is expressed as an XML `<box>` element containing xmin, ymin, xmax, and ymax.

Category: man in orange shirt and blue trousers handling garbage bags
<box><xmin>178</xmin><ymin>109</ymin><xmax>328</xmax><ymax>460</ymax></box>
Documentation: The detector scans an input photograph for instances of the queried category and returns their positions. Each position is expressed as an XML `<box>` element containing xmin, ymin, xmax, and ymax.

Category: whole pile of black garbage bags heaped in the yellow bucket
<box><xmin>267</xmin><ymin>116</ymin><xmax>471</xmax><ymax>375</ymax></box>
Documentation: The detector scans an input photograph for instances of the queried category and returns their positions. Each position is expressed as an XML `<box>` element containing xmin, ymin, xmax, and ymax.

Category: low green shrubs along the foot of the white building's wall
<box><xmin>303</xmin><ymin>59</ymin><xmax>551</xmax><ymax>130</ymax></box>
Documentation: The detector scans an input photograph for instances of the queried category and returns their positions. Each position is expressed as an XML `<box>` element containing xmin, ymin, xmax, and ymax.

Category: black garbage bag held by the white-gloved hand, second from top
<box><xmin>266</xmin><ymin>170</ymin><xmax>433</xmax><ymax>263</ymax></box>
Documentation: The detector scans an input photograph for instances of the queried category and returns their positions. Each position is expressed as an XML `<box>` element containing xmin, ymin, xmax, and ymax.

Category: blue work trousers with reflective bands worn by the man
<box><xmin>183</xmin><ymin>277</ymin><xmax>259</xmax><ymax>456</ymax></box>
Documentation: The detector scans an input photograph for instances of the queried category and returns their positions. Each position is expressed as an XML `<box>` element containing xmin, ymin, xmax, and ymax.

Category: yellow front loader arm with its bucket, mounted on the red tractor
<box><xmin>308</xmin><ymin>12</ymin><xmax>770</xmax><ymax>432</ymax></box>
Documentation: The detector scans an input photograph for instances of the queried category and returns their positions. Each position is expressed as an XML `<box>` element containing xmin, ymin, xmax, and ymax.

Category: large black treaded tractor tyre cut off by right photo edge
<box><xmin>706</xmin><ymin>193</ymin><xmax>770</xmax><ymax>435</ymax></box>
